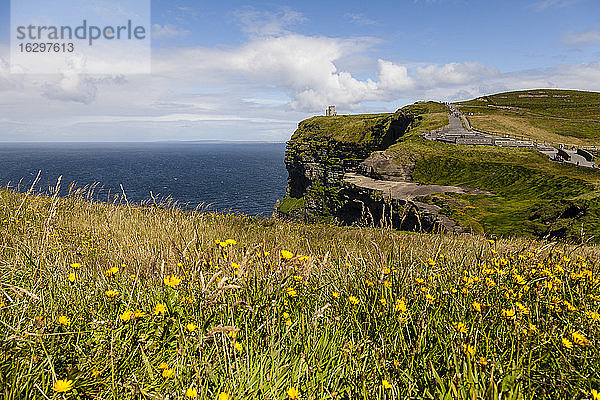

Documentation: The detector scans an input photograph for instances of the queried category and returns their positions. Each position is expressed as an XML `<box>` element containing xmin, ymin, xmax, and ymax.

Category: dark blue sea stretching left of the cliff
<box><xmin>0</xmin><ymin>142</ymin><xmax>287</xmax><ymax>216</ymax></box>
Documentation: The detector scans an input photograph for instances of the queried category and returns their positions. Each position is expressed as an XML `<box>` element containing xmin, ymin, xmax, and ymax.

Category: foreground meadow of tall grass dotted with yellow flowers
<box><xmin>0</xmin><ymin>186</ymin><xmax>600</xmax><ymax>399</ymax></box>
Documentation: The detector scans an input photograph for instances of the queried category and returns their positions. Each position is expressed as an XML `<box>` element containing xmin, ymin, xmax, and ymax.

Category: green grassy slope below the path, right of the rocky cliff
<box><xmin>389</xmin><ymin>98</ymin><xmax>600</xmax><ymax>240</ymax></box>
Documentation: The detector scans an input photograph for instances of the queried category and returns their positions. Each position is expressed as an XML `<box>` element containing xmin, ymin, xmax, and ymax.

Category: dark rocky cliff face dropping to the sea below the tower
<box><xmin>277</xmin><ymin>111</ymin><xmax>456</xmax><ymax>231</ymax></box>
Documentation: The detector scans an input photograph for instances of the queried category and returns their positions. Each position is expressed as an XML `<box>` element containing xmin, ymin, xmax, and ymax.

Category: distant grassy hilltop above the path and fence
<box><xmin>459</xmin><ymin>89</ymin><xmax>600</xmax><ymax>146</ymax></box>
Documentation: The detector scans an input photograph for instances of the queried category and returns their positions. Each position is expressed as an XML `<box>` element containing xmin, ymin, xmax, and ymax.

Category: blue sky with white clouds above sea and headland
<box><xmin>0</xmin><ymin>0</ymin><xmax>600</xmax><ymax>142</ymax></box>
